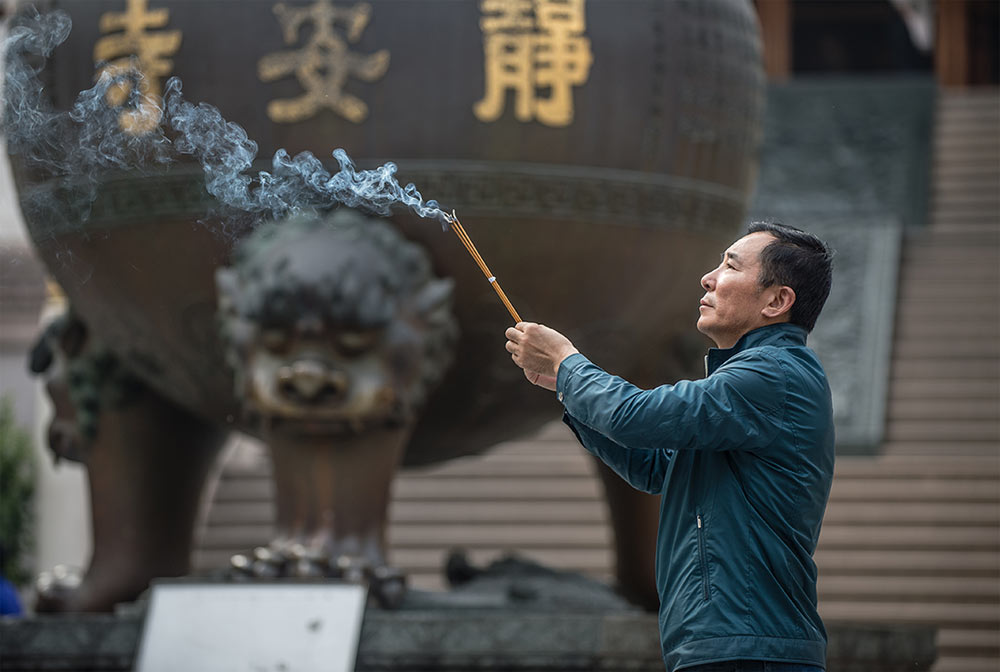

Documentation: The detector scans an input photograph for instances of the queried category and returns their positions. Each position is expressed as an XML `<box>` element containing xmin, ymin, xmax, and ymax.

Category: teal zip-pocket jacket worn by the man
<box><xmin>556</xmin><ymin>324</ymin><xmax>834</xmax><ymax>670</ymax></box>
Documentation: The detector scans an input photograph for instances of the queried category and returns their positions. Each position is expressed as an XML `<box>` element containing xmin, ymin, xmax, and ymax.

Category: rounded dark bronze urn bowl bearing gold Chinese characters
<box><xmin>7</xmin><ymin>0</ymin><xmax>763</xmax><ymax>612</ymax></box>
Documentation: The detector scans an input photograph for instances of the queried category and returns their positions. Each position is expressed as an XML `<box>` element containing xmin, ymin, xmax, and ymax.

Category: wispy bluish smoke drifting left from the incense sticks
<box><xmin>0</xmin><ymin>12</ymin><xmax>451</xmax><ymax>231</ymax></box>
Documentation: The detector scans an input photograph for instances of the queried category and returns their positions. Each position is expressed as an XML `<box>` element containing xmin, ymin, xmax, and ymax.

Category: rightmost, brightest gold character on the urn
<box><xmin>473</xmin><ymin>0</ymin><xmax>593</xmax><ymax>126</ymax></box>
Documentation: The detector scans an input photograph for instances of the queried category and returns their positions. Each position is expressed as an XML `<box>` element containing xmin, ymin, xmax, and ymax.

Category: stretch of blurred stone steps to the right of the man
<box><xmin>817</xmin><ymin>89</ymin><xmax>1000</xmax><ymax>672</ymax></box>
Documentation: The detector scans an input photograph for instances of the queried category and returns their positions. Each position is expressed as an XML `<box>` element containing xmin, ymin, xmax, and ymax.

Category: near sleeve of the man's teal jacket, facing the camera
<box><xmin>556</xmin><ymin>348</ymin><xmax>787</xmax><ymax>450</ymax></box>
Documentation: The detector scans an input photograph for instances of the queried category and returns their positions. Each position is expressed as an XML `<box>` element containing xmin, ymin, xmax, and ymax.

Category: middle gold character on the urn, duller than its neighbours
<box><xmin>257</xmin><ymin>0</ymin><xmax>389</xmax><ymax>123</ymax></box>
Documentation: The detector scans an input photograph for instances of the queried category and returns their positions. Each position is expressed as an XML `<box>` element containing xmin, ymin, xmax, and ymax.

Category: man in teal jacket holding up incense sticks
<box><xmin>506</xmin><ymin>223</ymin><xmax>834</xmax><ymax>672</ymax></box>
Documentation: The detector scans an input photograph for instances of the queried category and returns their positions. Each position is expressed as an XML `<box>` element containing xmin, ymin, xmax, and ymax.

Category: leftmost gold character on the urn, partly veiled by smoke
<box><xmin>94</xmin><ymin>0</ymin><xmax>181</xmax><ymax>135</ymax></box>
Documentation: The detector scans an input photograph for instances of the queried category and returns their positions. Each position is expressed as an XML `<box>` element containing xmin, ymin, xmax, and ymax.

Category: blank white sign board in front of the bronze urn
<box><xmin>135</xmin><ymin>582</ymin><xmax>368</xmax><ymax>672</ymax></box>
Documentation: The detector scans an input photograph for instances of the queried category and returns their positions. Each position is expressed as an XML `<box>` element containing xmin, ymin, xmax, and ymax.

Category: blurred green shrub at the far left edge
<box><xmin>0</xmin><ymin>396</ymin><xmax>35</xmax><ymax>585</ymax></box>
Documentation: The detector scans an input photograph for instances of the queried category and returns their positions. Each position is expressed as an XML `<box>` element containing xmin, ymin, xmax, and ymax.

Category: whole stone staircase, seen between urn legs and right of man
<box><xmin>195</xmin><ymin>89</ymin><xmax>1000</xmax><ymax>672</ymax></box>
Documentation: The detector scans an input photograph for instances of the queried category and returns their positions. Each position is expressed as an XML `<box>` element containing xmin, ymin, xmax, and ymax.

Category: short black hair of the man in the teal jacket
<box><xmin>747</xmin><ymin>222</ymin><xmax>833</xmax><ymax>331</ymax></box>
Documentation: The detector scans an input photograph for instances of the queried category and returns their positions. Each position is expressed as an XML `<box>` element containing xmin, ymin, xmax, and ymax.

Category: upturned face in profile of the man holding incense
<box><xmin>698</xmin><ymin>232</ymin><xmax>775</xmax><ymax>348</ymax></box>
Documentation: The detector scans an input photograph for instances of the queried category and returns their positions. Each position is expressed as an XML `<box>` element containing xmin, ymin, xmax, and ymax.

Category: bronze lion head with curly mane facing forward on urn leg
<box><xmin>217</xmin><ymin>216</ymin><xmax>455</xmax><ymax>434</ymax></box>
